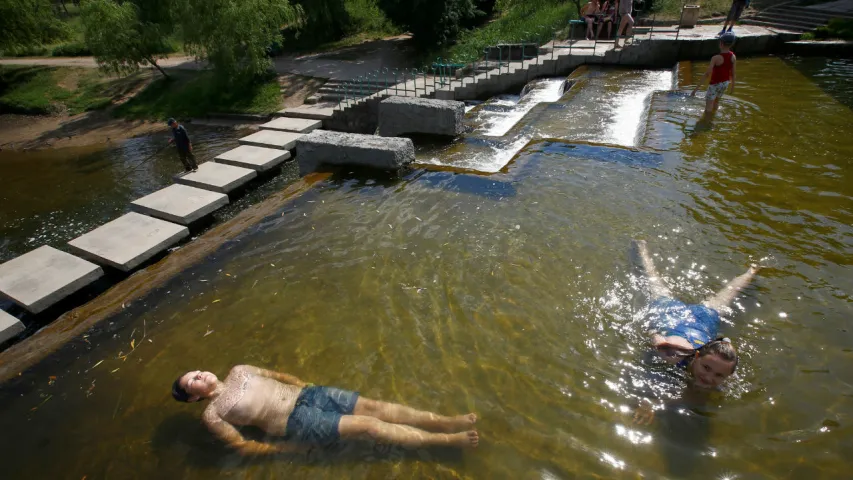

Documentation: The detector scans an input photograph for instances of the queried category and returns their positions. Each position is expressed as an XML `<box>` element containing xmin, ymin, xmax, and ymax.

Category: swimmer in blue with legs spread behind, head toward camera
<box><xmin>635</xmin><ymin>240</ymin><xmax>758</xmax><ymax>423</ymax></box>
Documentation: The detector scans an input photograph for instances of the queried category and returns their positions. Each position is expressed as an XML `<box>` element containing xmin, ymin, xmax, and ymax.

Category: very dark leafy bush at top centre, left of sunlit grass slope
<box><xmin>379</xmin><ymin>0</ymin><xmax>486</xmax><ymax>47</ymax></box>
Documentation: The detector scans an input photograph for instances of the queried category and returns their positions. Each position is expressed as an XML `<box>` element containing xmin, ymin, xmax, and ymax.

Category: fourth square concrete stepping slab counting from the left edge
<box><xmin>130</xmin><ymin>184</ymin><xmax>228</xmax><ymax>225</ymax></box>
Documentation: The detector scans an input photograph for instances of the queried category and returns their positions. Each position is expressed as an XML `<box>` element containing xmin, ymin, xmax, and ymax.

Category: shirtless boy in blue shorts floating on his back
<box><xmin>172</xmin><ymin>365</ymin><xmax>479</xmax><ymax>455</ymax></box>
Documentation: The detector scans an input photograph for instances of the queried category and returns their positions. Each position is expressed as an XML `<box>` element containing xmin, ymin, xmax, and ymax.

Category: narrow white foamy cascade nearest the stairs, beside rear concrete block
<box><xmin>478</xmin><ymin>78</ymin><xmax>565</xmax><ymax>137</ymax></box>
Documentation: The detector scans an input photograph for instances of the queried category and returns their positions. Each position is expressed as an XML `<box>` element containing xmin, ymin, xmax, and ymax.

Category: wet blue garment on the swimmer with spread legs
<box><xmin>647</xmin><ymin>297</ymin><xmax>720</xmax><ymax>348</ymax></box>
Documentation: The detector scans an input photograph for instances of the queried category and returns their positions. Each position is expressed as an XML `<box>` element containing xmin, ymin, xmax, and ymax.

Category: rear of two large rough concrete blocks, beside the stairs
<box><xmin>377</xmin><ymin>97</ymin><xmax>465</xmax><ymax>137</ymax></box>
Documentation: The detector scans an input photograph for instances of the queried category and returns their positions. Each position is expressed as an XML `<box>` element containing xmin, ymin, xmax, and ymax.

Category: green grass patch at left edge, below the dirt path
<box><xmin>0</xmin><ymin>66</ymin><xmax>120</xmax><ymax>115</ymax></box>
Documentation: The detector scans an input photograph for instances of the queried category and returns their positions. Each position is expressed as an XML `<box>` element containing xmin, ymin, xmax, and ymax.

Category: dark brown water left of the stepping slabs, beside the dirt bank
<box><xmin>0</xmin><ymin>125</ymin><xmax>293</xmax><ymax>262</ymax></box>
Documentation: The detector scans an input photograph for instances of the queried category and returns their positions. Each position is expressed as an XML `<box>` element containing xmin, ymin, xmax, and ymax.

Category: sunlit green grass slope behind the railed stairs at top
<box><xmin>440</xmin><ymin>0</ymin><xmax>577</xmax><ymax>61</ymax></box>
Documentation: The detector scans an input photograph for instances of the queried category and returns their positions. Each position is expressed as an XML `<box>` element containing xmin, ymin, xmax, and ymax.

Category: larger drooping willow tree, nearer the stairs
<box><xmin>178</xmin><ymin>0</ymin><xmax>303</xmax><ymax>82</ymax></box>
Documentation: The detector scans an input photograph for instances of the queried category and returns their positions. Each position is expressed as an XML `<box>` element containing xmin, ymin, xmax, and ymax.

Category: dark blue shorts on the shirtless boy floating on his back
<box><xmin>285</xmin><ymin>386</ymin><xmax>358</xmax><ymax>446</ymax></box>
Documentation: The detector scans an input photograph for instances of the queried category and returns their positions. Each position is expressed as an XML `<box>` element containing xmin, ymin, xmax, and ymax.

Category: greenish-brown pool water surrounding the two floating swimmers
<box><xmin>0</xmin><ymin>57</ymin><xmax>853</xmax><ymax>479</ymax></box>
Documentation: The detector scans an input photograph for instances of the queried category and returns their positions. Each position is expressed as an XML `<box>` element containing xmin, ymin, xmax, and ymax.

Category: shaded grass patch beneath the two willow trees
<box><xmin>115</xmin><ymin>72</ymin><xmax>281</xmax><ymax>120</ymax></box>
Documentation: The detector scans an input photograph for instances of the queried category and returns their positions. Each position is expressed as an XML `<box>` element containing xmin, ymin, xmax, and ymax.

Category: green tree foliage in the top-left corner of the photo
<box><xmin>0</xmin><ymin>0</ymin><xmax>68</xmax><ymax>50</ymax></box>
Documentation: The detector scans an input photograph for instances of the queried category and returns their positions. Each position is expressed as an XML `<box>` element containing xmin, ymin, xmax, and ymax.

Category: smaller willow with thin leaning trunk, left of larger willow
<box><xmin>81</xmin><ymin>0</ymin><xmax>172</xmax><ymax>78</ymax></box>
